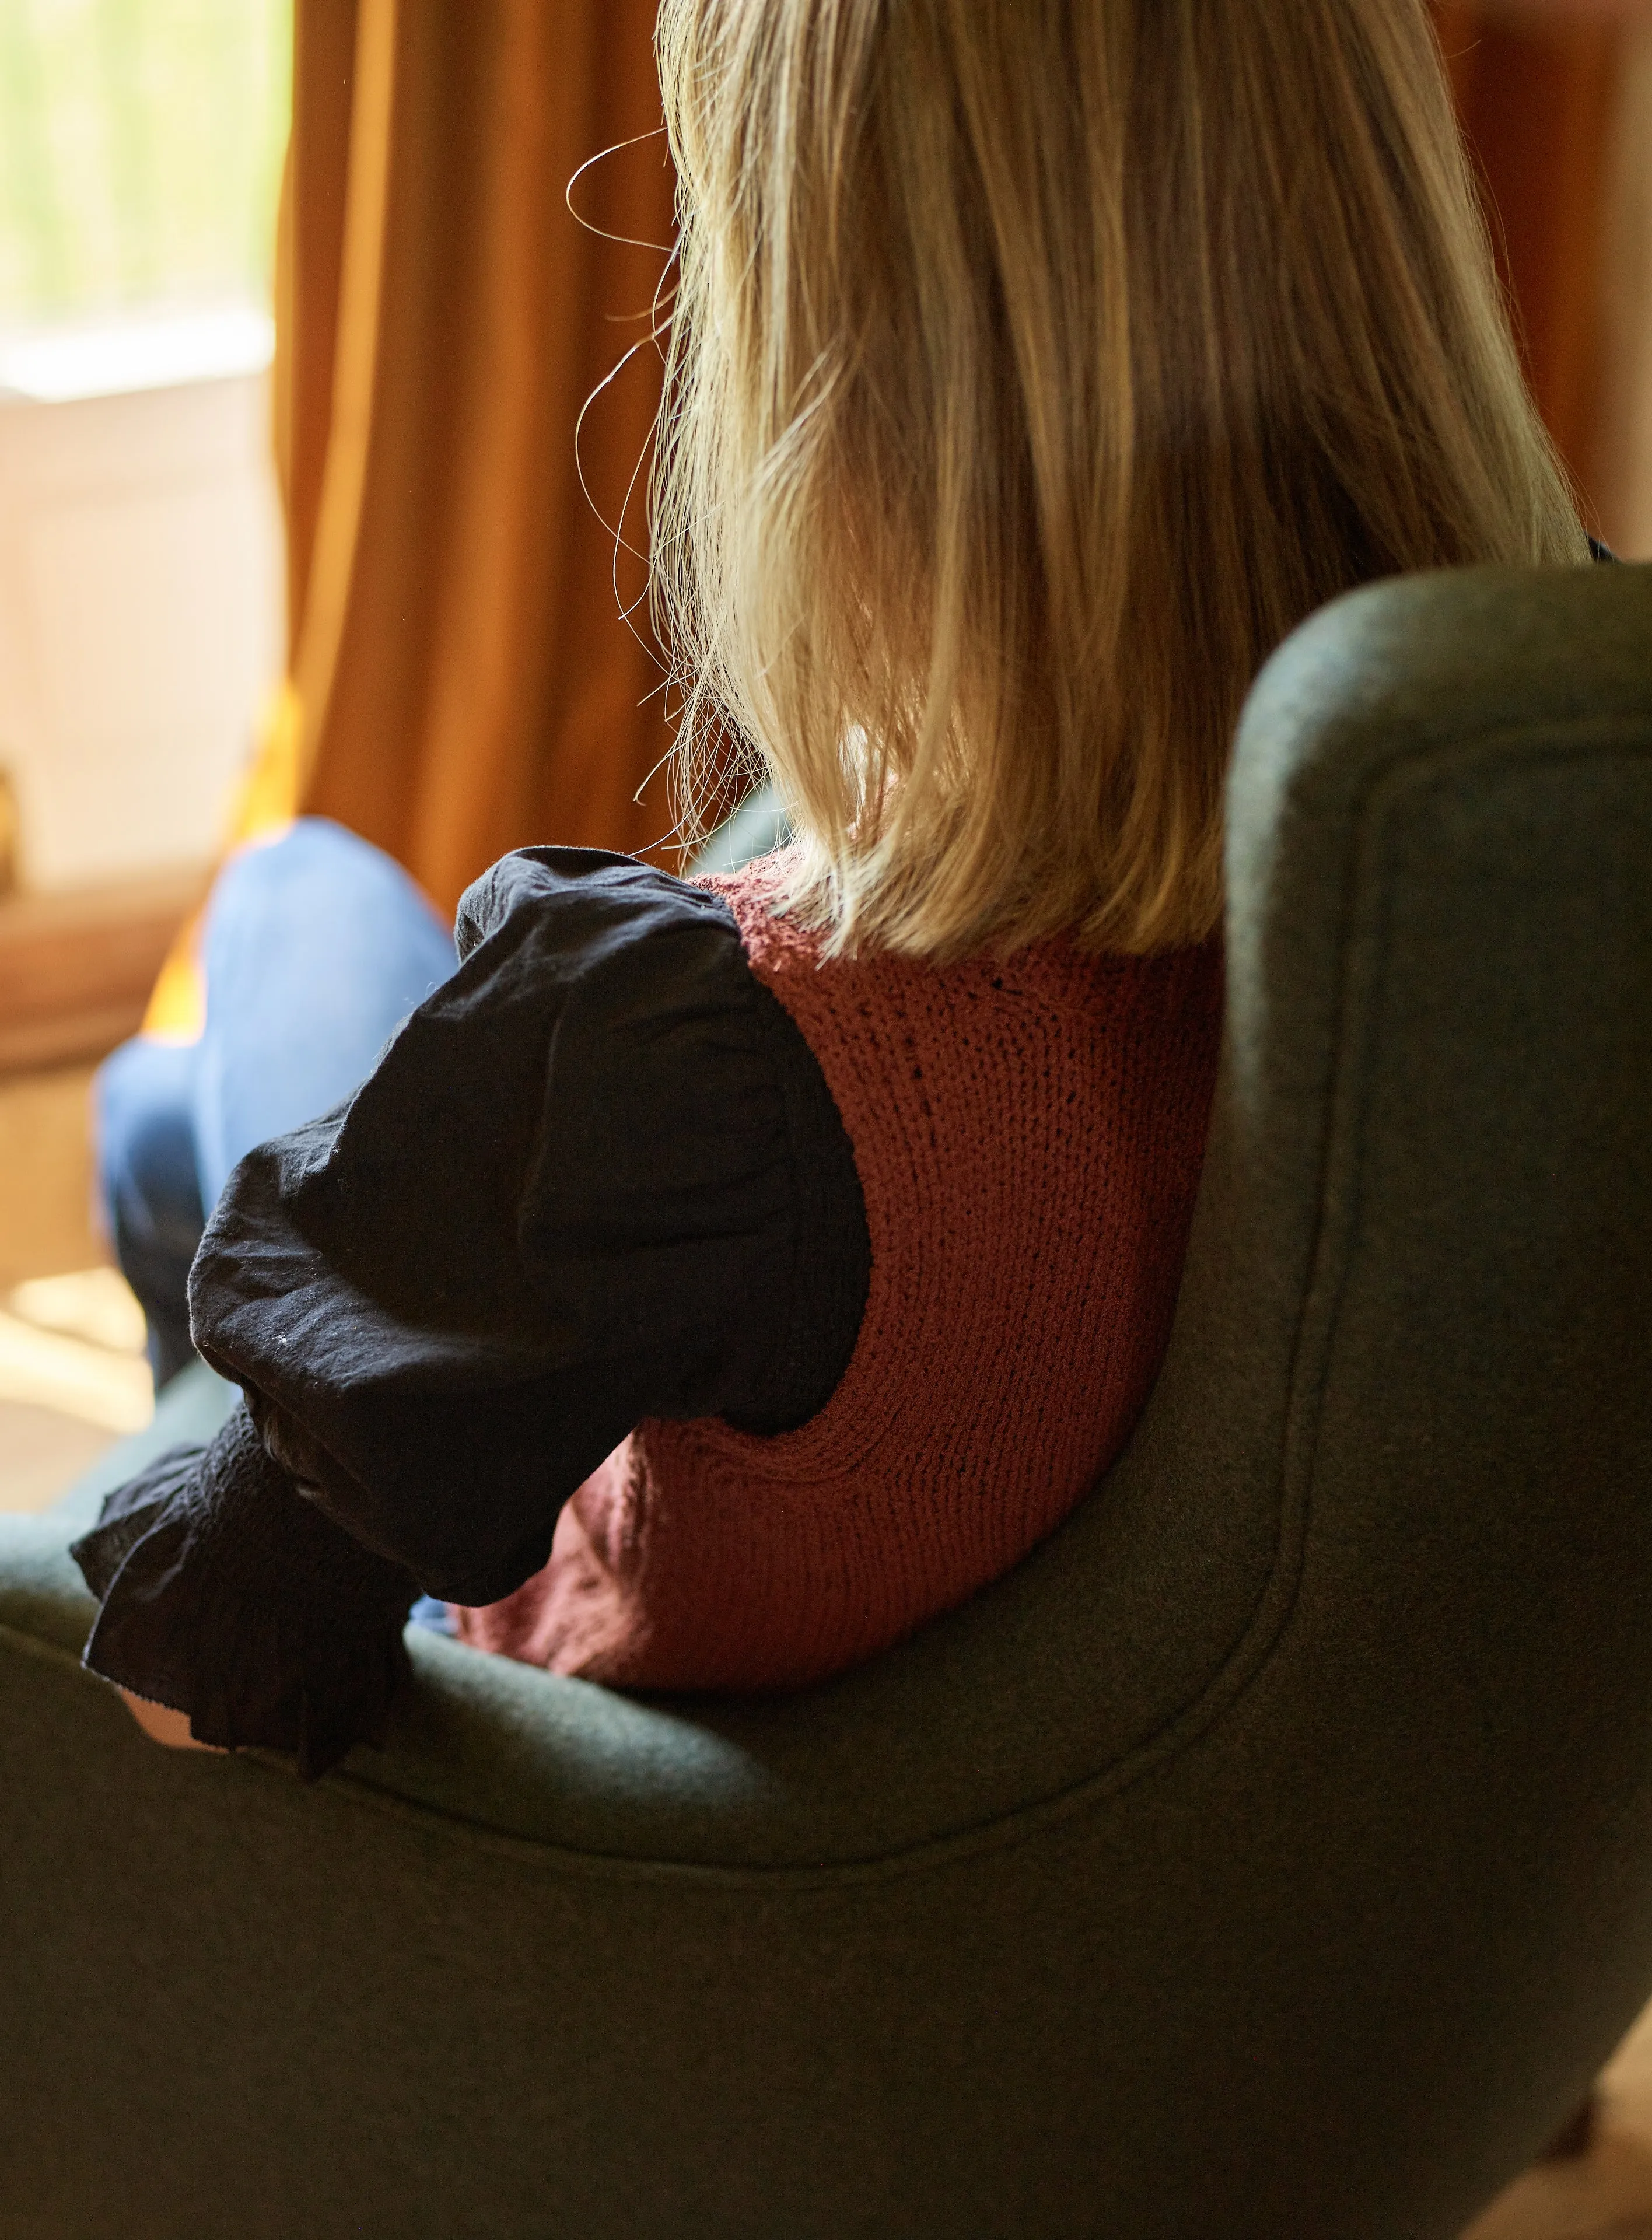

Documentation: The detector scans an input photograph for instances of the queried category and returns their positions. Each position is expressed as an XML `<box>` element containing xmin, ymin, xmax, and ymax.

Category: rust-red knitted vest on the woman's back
<box><xmin>461</xmin><ymin>867</ymin><xmax>1220</xmax><ymax>1689</ymax></box>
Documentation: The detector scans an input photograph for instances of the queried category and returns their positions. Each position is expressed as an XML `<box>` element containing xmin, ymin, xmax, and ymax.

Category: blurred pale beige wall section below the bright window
<box><xmin>0</xmin><ymin>374</ymin><xmax>282</xmax><ymax>889</ymax></box>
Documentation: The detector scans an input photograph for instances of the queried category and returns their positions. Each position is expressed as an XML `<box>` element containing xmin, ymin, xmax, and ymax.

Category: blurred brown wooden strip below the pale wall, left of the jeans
<box><xmin>0</xmin><ymin>864</ymin><xmax>208</xmax><ymax>1075</ymax></box>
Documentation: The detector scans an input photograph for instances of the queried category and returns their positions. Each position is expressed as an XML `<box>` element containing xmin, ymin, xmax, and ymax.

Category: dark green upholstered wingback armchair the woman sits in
<box><xmin>0</xmin><ymin>569</ymin><xmax>1652</xmax><ymax>2240</ymax></box>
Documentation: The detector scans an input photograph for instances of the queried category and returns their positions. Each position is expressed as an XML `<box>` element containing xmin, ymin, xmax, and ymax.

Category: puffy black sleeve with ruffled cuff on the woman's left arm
<box><xmin>76</xmin><ymin>849</ymin><xmax>871</xmax><ymax>1770</ymax></box>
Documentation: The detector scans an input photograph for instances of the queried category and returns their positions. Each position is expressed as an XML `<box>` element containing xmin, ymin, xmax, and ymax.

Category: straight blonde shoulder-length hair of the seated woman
<box><xmin>654</xmin><ymin>0</ymin><xmax>1587</xmax><ymax>957</ymax></box>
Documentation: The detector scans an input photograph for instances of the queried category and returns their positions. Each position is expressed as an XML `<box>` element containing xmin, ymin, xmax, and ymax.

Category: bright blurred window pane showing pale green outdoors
<box><xmin>0</xmin><ymin>0</ymin><xmax>293</xmax><ymax>327</ymax></box>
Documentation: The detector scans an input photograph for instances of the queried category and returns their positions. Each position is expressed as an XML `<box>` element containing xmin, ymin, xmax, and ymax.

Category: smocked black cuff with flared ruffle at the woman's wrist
<box><xmin>69</xmin><ymin>1407</ymin><xmax>419</xmax><ymax>1781</ymax></box>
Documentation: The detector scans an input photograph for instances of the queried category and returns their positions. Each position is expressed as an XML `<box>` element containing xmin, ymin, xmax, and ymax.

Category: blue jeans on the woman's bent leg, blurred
<box><xmin>94</xmin><ymin>818</ymin><xmax>457</xmax><ymax>1387</ymax></box>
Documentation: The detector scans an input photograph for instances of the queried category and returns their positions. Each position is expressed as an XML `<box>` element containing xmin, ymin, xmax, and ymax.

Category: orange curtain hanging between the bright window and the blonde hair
<box><xmin>279</xmin><ymin>0</ymin><xmax>671</xmax><ymax>909</ymax></box>
